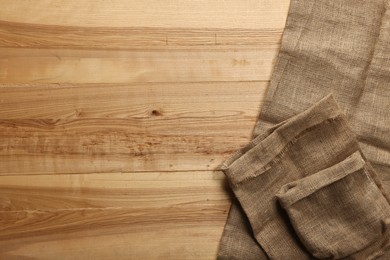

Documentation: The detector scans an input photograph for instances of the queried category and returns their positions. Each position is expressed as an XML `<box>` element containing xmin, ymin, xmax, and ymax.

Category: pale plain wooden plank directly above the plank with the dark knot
<box><xmin>0</xmin><ymin>47</ymin><xmax>277</xmax><ymax>83</ymax></box>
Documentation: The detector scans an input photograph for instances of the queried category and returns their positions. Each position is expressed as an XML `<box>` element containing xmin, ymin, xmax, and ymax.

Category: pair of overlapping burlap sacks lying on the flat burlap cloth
<box><xmin>220</xmin><ymin>95</ymin><xmax>390</xmax><ymax>259</ymax></box>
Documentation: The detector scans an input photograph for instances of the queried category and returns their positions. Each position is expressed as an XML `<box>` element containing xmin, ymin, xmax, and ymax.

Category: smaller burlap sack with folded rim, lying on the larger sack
<box><xmin>277</xmin><ymin>152</ymin><xmax>390</xmax><ymax>259</ymax></box>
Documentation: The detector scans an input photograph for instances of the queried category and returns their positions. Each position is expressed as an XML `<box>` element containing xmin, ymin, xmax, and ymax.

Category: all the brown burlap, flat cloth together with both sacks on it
<box><xmin>218</xmin><ymin>0</ymin><xmax>390</xmax><ymax>260</ymax></box>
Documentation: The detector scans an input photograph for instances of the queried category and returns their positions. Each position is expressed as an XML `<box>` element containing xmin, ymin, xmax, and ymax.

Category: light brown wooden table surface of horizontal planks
<box><xmin>0</xmin><ymin>0</ymin><xmax>289</xmax><ymax>260</ymax></box>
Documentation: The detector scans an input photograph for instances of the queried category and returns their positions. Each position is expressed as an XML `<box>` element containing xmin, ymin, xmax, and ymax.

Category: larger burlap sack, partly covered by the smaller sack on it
<box><xmin>219</xmin><ymin>96</ymin><xmax>390</xmax><ymax>259</ymax></box>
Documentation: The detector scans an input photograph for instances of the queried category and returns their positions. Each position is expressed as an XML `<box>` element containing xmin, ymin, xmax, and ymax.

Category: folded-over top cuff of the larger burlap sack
<box><xmin>221</xmin><ymin>94</ymin><xmax>341</xmax><ymax>185</ymax></box>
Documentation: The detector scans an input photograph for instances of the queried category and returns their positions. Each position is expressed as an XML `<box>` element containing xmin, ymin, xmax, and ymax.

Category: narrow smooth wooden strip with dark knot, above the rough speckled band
<box><xmin>0</xmin><ymin>81</ymin><xmax>268</xmax><ymax>120</ymax></box>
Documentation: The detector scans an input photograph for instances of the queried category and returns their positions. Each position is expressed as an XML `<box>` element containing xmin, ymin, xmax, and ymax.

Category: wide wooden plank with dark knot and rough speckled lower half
<box><xmin>0</xmin><ymin>82</ymin><xmax>267</xmax><ymax>175</ymax></box>
